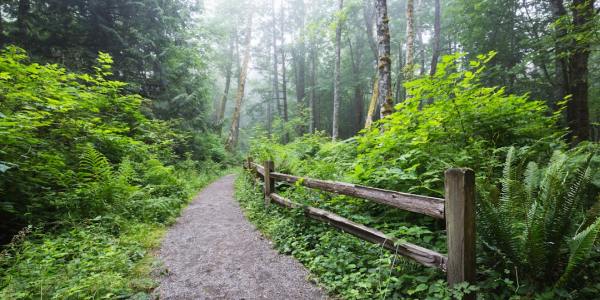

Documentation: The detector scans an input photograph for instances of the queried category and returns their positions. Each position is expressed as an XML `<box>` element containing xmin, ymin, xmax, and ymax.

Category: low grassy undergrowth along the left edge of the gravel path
<box><xmin>0</xmin><ymin>166</ymin><xmax>223</xmax><ymax>299</ymax></box>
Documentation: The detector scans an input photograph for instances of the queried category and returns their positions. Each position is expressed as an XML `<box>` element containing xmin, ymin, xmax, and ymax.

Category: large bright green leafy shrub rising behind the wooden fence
<box><xmin>354</xmin><ymin>53</ymin><xmax>563</xmax><ymax>196</ymax></box>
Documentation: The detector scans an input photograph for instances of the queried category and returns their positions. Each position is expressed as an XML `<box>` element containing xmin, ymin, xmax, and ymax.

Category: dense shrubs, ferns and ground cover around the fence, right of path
<box><xmin>238</xmin><ymin>55</ymin><xmax>600</xmax><ymax>299</ymax></box>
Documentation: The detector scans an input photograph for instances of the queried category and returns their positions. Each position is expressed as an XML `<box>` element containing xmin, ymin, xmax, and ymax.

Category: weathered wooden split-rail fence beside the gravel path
<box><xmin>244</xmin><ymin>158</ymin><xmax>476</xmax><ymax>290</ymax></box>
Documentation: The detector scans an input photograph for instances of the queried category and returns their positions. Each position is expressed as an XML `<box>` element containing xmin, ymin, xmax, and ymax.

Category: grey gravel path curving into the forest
<box><xmin>155</xmin><ymin>175</ymin><xmax>326</xmax><ymax>299</ymax></box>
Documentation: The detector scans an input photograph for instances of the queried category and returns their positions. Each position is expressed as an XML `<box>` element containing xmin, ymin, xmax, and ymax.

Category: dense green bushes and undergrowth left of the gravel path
<box><xmin>0</xmin><ymin>47</ymin><xmax>224</xmax><ymax>299</ymax></box>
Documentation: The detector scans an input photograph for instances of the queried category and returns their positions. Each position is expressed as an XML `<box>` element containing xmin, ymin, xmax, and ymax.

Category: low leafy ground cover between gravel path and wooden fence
<box><xmin>236</xmin><ymin>173</ymin><xmax>474</xmax><ymax>299</ymax></box>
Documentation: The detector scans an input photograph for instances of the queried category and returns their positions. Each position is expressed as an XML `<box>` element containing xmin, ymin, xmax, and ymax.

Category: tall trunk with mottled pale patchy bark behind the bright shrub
<box><xmin>375</xmin><ymin>0</ymin><xmax>394</xmax><ymax>118</ymax></box>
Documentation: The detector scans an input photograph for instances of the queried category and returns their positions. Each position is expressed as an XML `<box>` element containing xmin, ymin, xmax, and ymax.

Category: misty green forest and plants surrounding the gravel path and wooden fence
<box><xmin>0</xmin><ymin>0</ymin><xmax>600</xmax><ymax>299</ymax></box>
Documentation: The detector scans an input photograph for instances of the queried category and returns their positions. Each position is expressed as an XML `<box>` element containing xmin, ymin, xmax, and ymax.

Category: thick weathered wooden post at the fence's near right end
<box><xmin>444</xmin><ymin>169</ymin><xmax>476</xmax><ymax>299</ymax></box>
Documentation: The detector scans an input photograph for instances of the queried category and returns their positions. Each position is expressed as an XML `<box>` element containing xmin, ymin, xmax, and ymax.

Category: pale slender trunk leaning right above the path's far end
<box><xmin>226</xmin><ymin>8</ymin><xmax>254</xmax><ymax>151</ymax></box>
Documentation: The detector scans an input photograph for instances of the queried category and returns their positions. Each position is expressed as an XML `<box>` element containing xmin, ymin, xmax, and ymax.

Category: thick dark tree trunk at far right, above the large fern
<box><xmin>567</xmin><ymin>0</ymin><xmax>596</xmax><ymax>143</ymax></box>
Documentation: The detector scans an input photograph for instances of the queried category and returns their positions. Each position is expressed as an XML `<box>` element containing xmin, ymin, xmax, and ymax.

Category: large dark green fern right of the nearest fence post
<box><xmin>478</xmin><ymin>148</ymin><xmax>600</xmax><ymax>287</ymax></box>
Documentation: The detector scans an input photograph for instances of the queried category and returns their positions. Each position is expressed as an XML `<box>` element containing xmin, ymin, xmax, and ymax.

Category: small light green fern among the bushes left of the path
<box><xmin>78</xmin><ymin>145</ymin><xmax>112</xmax><ymax>182</ymax></box>
